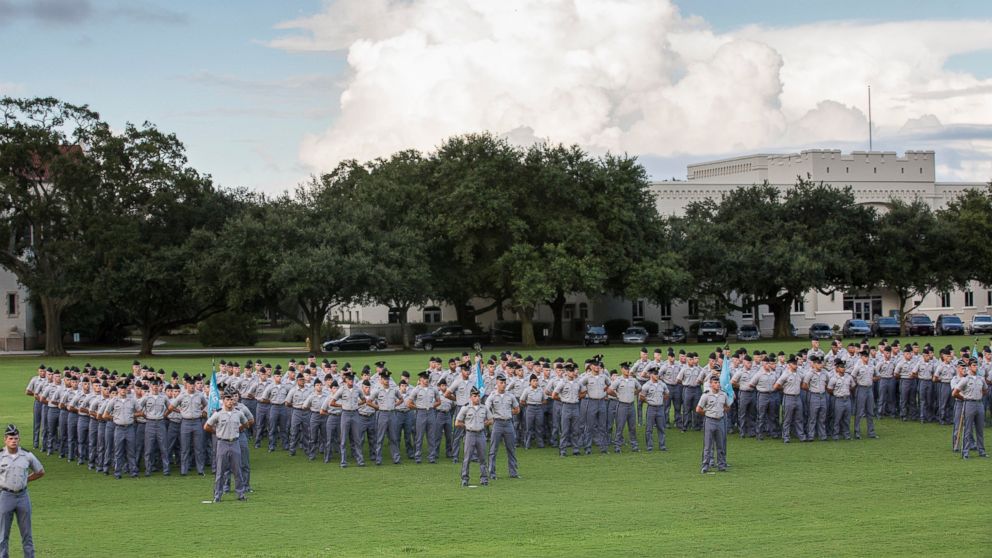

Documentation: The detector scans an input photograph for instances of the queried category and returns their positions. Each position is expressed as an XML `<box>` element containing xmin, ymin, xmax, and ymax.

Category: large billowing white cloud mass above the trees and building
<box><xmin>270</xmin><ymin>0</ymin><xmax>992</xmax><ymax>182</ymax></box>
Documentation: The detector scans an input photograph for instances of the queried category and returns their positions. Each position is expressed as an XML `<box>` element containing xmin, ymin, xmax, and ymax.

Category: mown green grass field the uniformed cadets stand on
<box><xmin>0</xmin><ymin>338</ymin><xmax>992</xmax><ymax>557</ymax></box>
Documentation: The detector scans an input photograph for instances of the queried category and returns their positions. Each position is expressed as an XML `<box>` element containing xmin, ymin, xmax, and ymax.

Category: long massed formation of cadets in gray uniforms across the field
<box><xmin>19</xmin><ymin>340</ymin><xmax>992</xmax><ymax>490</ymax></box>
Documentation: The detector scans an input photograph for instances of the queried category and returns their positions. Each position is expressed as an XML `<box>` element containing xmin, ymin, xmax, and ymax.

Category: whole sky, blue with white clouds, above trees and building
<box><xmin>0</xmin><ymin>0</ymin><xmax>992</xmax><ymax>194</ymax></box>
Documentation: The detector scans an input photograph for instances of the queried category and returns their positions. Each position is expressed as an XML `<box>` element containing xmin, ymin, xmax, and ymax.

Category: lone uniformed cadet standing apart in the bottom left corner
<box><xmin>0</xmin><ymin>424</ymin><xmax>45</xmax><ymax>558</ymax></box>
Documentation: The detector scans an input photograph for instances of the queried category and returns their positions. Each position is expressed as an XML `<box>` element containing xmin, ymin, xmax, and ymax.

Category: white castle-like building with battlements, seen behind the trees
<box><xmin>333</xmin><ymin>149</ymin><xmax>992</xmax><ymax>338</ymax></box>
